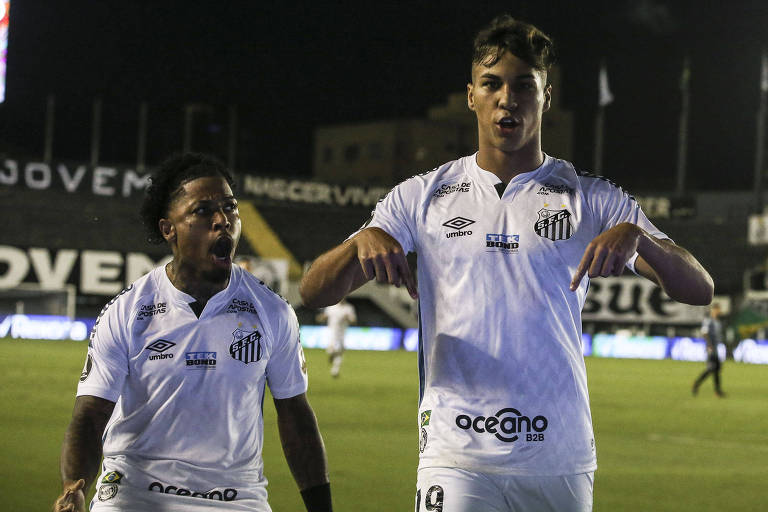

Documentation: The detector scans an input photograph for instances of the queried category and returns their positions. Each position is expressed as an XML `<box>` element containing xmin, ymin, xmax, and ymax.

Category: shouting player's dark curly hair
<box><xmin>140</xmin><ymin>153</ymin><xmax>235</xmax><ymax>244</ymax></box>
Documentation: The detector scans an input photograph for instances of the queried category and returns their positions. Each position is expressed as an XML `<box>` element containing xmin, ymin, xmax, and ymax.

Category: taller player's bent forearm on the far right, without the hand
<box><xmin>637</xmin><ymin>234</ymin><xmax>715</xmax><ymax>306</ymax></box>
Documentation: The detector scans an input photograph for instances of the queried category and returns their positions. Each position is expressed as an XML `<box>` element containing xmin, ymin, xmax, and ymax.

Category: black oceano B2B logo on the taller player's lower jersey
<box><xmin>456</xmin><ymin>407</ymin><xmax>549</xmax><ymax>443</ymax></box>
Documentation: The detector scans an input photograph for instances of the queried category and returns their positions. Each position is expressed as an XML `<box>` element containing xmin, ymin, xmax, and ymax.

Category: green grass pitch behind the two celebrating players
<box><xmin>0</xmin><ymin>339</ymin><xmax>768</xmax><ymax>512</ymax></box>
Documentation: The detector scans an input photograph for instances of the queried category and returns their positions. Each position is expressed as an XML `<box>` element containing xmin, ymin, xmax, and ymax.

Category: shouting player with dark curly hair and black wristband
<box><xmin>54</xmin><ymin>154</ymin><xmax>331</xmax><ymax>512</ymax></box>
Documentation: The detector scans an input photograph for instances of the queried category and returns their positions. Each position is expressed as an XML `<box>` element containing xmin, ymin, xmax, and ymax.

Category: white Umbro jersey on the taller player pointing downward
<box><xmin>368</xmin><ymin>155</ymin><xmax>667</xmax><ymax>475</ymax></box>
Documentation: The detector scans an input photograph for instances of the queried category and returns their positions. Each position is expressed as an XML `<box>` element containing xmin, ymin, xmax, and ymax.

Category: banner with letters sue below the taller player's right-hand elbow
<box><xmin>581</xmin><ymin>277</ymin><xmax>705</xmax><ymax>325</ymax></box>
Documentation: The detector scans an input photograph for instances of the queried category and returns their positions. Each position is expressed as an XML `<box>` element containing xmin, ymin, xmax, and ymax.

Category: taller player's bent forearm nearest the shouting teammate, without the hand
<box><xmin>299</xmin><ymin>240</ymin><xmax>365</xmax><ymax>308</ymax></box>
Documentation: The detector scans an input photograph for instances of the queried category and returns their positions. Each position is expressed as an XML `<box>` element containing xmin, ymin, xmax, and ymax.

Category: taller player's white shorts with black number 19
<box><xmin>416</xmin><ymin>468</ymin><xmax>594</xmax><ymax>512</ymax></box>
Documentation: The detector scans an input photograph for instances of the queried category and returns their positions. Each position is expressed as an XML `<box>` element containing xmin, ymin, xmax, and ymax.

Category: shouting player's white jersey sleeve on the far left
<box><xmin>77</xmin><ymin>297</ymin><xmax>130</xmax><ymax>402</ymax></box>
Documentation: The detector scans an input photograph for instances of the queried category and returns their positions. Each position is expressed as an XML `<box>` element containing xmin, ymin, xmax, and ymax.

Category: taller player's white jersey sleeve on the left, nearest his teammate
<box><xmin>361</xmin><ymin>178</ymin><xmax>421</xmax><ymax>253</ymax></box>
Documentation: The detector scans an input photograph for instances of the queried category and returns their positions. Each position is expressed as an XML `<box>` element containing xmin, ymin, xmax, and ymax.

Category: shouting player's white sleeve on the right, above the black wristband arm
<box><xmin>267</xmin><ymin>304</ymin><xmax>307</xmax><ymax>399</ymax></box>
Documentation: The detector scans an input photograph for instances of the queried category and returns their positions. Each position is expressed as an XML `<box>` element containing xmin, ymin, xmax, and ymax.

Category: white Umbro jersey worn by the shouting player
<box><xmin>77</xmin><ymin>266</ymin><xmax>307</xmax><ymax>510</ymax></box>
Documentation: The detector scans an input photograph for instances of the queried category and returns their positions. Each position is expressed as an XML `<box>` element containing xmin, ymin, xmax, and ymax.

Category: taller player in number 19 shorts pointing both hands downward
<box><xmin>300</xmin><ymin>16</ymin><xmax>714</xmax><ymax>512</ymax></box>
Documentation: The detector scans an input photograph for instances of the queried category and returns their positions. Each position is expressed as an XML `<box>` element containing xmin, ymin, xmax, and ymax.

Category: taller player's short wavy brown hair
<box><xmin>472</xmin><ymin>14</ymin><xmax>556</xmax><ymax>71</ymax></box>
